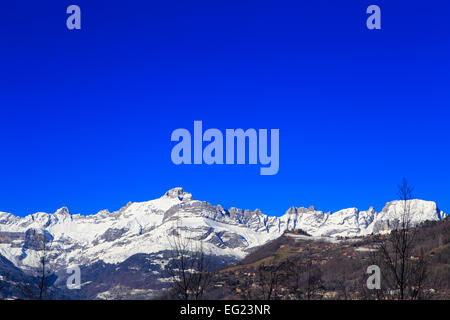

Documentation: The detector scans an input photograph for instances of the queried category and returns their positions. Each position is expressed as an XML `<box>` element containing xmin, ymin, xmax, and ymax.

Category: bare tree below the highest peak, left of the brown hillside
<box><xmin>168</xmin><ymin>223</ymin><xmax>212</xmax><ymax>300</ymax></box>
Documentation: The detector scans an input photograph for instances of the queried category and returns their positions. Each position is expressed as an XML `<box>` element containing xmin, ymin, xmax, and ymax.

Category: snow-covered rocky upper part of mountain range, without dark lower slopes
<box><xmin>0</xmin><ymin>188</ymin><xmax>445</xmax><ymax>270</ymax></box>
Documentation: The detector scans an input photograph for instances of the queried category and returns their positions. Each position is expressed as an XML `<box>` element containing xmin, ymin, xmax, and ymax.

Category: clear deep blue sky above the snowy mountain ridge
<box><xmin>0</xmin><ymin>0</ymin><xmax>450</xmax><ymax>215</ymax></box>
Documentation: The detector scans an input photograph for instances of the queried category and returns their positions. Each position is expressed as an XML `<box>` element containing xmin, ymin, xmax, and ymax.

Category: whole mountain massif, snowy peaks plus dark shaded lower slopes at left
<box><xmin>0</xmin><ymin>188</ymin><xmax>446</xmax><ymax>299</ymax></box>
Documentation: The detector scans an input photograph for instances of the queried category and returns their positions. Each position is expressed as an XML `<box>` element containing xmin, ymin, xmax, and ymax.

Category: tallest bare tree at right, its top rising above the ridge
<box><xmin>372</xmin><ymin>179</ymin><xmax>427</xmax><ymax>300</ymax></box>
